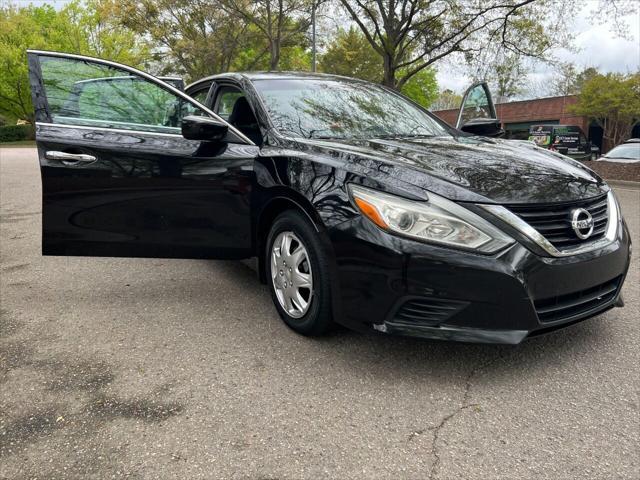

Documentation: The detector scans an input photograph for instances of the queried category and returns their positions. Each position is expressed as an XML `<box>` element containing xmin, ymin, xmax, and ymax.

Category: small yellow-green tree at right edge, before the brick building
<box><xmin>571</xmin><ymin>72</ymin><xmax>640</xmax><ymax>150</ymax></box>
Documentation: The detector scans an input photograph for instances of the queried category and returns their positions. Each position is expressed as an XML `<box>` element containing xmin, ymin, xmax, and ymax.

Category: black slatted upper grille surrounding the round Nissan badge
<box><xmin>505</xmin><ymin>194</ymin><xmax>609</xmax><ymax>251</ymax></box>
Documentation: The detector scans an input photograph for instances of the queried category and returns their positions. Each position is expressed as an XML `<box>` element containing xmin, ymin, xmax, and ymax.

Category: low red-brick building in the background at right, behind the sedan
<box><xmin>433</xmin><ymin>95</ymin><xmax>640</xmax><ymax>151</ymax></box>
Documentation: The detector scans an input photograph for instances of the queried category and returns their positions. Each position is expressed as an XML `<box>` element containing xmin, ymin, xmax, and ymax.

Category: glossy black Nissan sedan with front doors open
<box><xmin>23</xmin><ymin>51</ymin><xmax>630</xmax><ymax>343</ymax></box>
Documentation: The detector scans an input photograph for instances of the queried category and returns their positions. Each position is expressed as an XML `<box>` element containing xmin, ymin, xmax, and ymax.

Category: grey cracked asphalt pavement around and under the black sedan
<box><xmin>0</xmin><ymin>147</ymin><xmax>640</xmax><ymax>479</ymax></box>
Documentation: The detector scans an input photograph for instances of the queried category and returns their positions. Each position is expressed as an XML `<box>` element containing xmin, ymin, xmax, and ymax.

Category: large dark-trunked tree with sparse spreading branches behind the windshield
<box><xmin>341</xmin><ymin>0</ymin><xmax>564</xmax><ymax>89</ymax></box>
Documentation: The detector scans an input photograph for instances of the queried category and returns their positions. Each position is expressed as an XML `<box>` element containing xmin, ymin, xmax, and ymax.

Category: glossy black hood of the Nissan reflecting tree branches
<box><xmin>298</xmin><ymin>136</ymin><xmax>609</xmax><ymax>203</ymax></box>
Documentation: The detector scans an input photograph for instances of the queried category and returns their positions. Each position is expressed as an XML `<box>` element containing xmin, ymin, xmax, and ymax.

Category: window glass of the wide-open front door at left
<box><xmin>40</xmin><ymin>56</ymin><xmax>206</xmax><ymax>134</ymax></box>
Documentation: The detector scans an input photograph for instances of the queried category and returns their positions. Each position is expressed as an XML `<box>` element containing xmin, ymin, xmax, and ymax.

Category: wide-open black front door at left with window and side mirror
<box><xmin>28</xmin><ymin>50</ymin><xmax>258</xmax><ymax>258</ymax></box>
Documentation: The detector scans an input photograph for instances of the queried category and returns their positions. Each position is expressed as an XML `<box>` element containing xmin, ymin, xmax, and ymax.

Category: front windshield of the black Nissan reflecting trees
<box><xmin>254</xmin><ymin>79</ymin><xmax>448</xmax><ymax>138</ymax></box>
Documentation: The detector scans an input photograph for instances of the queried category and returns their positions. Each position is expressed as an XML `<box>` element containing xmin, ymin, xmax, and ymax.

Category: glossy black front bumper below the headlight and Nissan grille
<box><xmin>330</xmin><ymin>218</ymin><xmax>630</xmax><ymax>344</ymax></box>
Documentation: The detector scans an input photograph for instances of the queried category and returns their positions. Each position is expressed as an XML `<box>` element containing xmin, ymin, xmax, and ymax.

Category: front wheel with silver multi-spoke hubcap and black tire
<box><xmin>265</xmin><ymin>210</ymin><xmax>333</xmax><ymax>335</ymax></box>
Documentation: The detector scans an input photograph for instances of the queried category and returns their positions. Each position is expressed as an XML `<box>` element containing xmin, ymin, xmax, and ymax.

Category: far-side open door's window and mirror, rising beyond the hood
<box><xmin>456</xmin><ymin>82</ymin><xmax>504</xmax><ymax>137</ymax></box>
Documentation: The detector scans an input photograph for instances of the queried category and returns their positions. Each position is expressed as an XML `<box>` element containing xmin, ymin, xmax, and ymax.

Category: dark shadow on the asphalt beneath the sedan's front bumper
<box><xmin>210</xmin><ymin>262</ymin><xmax>617</xmax><ymax>382</ymax></box>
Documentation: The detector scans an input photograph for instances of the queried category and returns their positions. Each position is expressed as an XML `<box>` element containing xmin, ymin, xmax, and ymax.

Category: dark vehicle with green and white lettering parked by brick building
<box><xmin>529</xmin><ymin>125</ymin><xmax>600</xmax><ymax>161</ymax></box>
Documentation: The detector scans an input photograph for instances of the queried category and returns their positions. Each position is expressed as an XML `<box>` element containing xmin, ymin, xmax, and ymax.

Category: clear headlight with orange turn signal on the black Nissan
<box><xmin>349</xmin><ymin>184</ymin><xmax>514</xmax><ymax>253</ymax></box>
